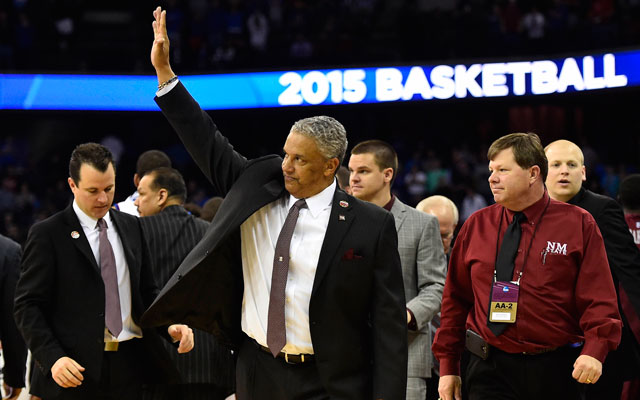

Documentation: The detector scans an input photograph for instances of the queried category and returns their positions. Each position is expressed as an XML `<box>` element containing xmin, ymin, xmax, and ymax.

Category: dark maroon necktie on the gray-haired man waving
<box><xmin>267</xmin><ymin>199</ymin><xmax>307</xmax><ymax>357</ymax></box>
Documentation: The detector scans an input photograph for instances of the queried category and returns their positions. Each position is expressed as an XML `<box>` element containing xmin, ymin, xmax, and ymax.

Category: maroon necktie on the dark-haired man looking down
<box><xmin>98</xmin><ymin>218</ymin><xmax>122</xmax><ymax>337</ymax></box>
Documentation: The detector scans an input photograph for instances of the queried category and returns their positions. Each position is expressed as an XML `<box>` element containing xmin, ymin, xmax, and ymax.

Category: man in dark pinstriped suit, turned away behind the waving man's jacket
<box><xmin>135</xmin><ymin>167</ymin><xmax>235</xmax><ymax>400</ymax></box>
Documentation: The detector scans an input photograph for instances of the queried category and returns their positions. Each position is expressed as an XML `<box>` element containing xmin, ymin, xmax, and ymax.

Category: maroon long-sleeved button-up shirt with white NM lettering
<box><xmin>433</xmin><ymin>191</ymin><xmax>622</xmax><ymax>375</ymax></box>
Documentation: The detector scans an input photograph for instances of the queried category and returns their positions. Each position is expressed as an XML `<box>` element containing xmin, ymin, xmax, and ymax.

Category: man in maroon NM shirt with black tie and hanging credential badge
<box><xmin>433</xmin><ymin>133</ymin><xmax>621</xmax><ymax>400</ymax></box>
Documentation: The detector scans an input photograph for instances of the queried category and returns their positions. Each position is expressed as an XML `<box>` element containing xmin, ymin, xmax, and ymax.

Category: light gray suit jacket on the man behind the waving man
<box><xmin>391</xmin><ymin>198</ymin><xmax>447</xmax><ymax>378</ymax></box>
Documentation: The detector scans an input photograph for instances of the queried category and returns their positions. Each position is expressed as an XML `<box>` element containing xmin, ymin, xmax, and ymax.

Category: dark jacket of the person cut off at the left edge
<box><xmin>0</xmin><ymin>235</ymin><xmax>27</xmax><ymax>388</ymax></box>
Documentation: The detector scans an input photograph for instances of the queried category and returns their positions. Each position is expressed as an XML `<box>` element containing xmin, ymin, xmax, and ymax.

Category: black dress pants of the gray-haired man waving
<box><xmin>236</xmin><ymin>337</ymin><xmax>329</xmax><ymax>400</ymax></box>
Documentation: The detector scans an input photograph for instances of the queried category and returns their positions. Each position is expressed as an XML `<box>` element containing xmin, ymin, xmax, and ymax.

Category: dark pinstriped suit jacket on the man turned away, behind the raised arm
<box><xmin>140</xmin><ymin>205</ymin><xmax>235</xmax><ymax>393</ymax></box>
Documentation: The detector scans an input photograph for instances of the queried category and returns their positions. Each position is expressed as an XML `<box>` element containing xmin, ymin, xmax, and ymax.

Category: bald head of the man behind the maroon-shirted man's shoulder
<box><xmin>544</xmin><ymin>140</ymin><xmax>587</xmax><ymax>202</ymax></box>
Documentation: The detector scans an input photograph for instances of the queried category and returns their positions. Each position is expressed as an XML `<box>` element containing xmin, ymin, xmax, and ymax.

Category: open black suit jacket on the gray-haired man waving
<box><xmin>143</xmin><ymin>84</ymin><xmax>407</xmax><ymax>400</ymax></box>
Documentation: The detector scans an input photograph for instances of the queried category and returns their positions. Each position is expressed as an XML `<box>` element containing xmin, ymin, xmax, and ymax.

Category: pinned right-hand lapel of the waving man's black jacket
<box><xmin>311</xmin><ymin>190</ymin><xmax>355</xmax><ymax>296</ymax></box>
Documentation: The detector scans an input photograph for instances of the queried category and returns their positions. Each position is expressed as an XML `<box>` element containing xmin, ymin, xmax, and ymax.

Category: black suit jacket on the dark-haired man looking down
<box><xmin>15</xmin><ymin>206</ymin><xmax>175</xmax><ymax>398</ymax></box>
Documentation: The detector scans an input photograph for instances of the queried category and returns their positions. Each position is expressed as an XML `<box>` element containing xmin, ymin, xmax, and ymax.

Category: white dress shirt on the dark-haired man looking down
<box><xmin>73</xmin><ymin>200</ymin><xmax>142</xmax><ymax>342</ymax></box>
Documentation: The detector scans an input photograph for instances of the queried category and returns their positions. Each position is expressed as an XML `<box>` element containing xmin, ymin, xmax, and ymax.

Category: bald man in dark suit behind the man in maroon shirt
<box><xmin>545</xmin><ymin>140</ymin><xmax>640</xmax><ymax>400</ymax></box>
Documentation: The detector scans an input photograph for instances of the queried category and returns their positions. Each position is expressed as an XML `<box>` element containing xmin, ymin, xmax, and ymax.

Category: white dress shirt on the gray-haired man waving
<box><xmin>240</xmin><ymin>180</ymin><xmax>336</xmax><ymax>354</ymax></box>
